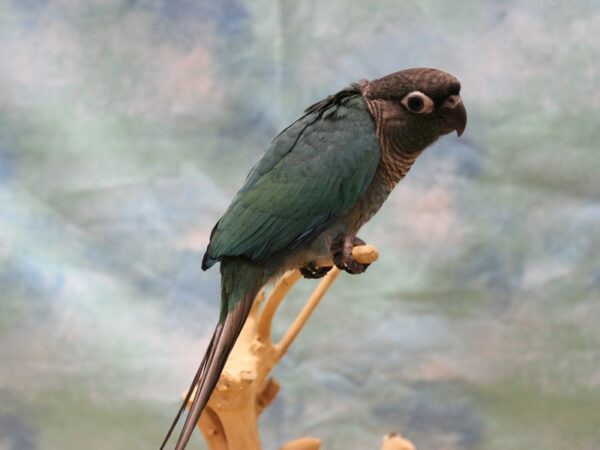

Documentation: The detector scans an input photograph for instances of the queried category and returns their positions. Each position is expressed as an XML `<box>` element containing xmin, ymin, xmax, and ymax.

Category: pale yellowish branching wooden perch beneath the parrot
<box><xmin>189</xmin><ymin>245</ymin><xmax>415</xmax><ymax>450</ymax></box>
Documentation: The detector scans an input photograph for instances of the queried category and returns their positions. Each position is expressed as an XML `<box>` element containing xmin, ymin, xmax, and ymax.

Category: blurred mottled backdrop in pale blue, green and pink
<box><xmin>0</xmin><ymin>0</ymin><xmax>600</xmax><ymax>450</ymax></box>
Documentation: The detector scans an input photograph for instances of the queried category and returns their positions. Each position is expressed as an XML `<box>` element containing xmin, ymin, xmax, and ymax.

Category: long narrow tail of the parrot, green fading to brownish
<box><xmin>160</xmin><ymin>258</ymin><xmax>267</xmax><ymax>450</ymax></box>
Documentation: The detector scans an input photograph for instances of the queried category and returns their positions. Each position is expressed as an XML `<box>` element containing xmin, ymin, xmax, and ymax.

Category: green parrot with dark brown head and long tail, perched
<box><xmin>160</xmin><ymin>68</ymin><xmax>467</xmax><ymax>450</ymax></box>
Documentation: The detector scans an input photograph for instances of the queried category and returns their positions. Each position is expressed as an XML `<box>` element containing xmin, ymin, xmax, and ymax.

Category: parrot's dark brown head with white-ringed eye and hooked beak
<box><xmin>361</xmin><ymin>68</ymin><xmax>467</xmax><ymax>150</ymax></box>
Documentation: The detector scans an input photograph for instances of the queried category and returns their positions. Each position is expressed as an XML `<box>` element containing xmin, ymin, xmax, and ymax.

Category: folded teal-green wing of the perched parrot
<box><xmin>202</xmin><ymin>89</ymin><xmax>381</xmax><ymax>269</ymax></box>
